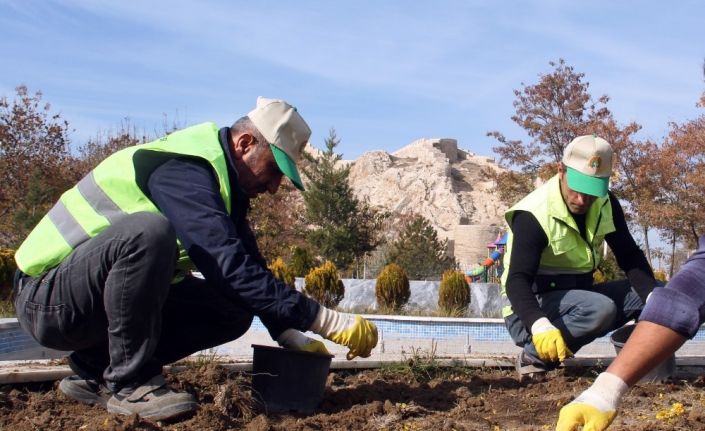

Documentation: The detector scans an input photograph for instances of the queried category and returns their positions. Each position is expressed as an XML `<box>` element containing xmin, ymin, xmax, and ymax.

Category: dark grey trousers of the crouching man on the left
<box><xmin>15</xmin><ymin>213</ymin><xmax>253</xmax><ymax>390</ymax></box>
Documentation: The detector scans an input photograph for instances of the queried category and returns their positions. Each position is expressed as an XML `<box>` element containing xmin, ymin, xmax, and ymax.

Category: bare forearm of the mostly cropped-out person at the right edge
<box><xmin>607</xmin><ymin>321</ymin><xmax>686</xmax><ymax>386</ymax></box>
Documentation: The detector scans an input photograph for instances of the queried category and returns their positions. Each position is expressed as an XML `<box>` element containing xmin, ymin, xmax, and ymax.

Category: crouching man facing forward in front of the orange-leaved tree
<box><xmin>502</xmin><ymin>135</ymin><xmax>656</xmax><ymax>377</ymax></box>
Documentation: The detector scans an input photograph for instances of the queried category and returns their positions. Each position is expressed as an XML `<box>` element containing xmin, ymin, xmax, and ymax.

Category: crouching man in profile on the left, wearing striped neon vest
<box><xmin>14</xmin><ymin>97</ymin><xmax>377</xmax><ymax>420</ymax></box>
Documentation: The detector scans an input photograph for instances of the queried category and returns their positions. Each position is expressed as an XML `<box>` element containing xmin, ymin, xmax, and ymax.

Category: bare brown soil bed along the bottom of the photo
<box><xmin>0</xmin><ymin>363</ymin><xmax>705</xmax><ymax>431</ymax></box>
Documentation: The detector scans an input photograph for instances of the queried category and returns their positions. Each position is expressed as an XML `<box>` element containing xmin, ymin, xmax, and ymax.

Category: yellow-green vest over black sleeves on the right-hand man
<box><xmin>502</xmin><ymin>175</ymin><xmax>615</xmax><ymax>317</ymax></box>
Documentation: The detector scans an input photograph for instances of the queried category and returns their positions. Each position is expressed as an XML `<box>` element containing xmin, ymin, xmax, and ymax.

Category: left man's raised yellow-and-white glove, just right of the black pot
<box><xmin>310</xmin><ymin>306</ymin><xmax>377</xmax><ymax>360</ymax></box>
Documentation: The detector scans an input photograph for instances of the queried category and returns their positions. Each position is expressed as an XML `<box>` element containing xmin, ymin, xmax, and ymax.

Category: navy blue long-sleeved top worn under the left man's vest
<box><xmin>147</xmin><ymin>128</ymin><xmax>319</xmax><ymax>339</ymax></box>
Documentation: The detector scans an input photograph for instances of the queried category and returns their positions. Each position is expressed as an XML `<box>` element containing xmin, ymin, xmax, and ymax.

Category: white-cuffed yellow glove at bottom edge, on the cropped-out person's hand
<box><xmin>556</xmin><ymin>372</ymin><xmax>629</xmax><ymax>431</ymax></box>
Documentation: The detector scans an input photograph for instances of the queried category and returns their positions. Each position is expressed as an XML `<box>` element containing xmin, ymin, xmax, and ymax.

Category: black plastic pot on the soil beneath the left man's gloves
<box><xmin>252</xmin><ymin>344</ymin><xmax>333</xmax><ymax>414</ymax></box>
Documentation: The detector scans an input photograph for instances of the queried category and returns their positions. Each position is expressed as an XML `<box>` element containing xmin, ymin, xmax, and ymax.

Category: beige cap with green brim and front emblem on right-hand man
<box><xmin>562</xmin><ymin>134</ymin><xmax>613</xmax><ymax>198</ymax></box>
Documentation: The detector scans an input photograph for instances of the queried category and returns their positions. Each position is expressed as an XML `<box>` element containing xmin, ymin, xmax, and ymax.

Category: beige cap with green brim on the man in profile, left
<box><xmin>247</xmin><ymin>97</ymin><xmax>311</xmax><ymax>190</ymax></box>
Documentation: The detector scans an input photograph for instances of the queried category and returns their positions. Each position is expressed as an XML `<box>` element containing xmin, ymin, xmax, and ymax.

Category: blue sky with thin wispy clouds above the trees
<box><xmin>0</xmin><ymin>0</ymin><xmax>705</xmax><ymax>159</ymax></box>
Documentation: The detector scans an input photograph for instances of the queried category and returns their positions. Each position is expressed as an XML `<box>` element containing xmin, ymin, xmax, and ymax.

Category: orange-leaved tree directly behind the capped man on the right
<box><xmin>486</xmin><ymin>59</ymin><xmax>668</xmax><ymax>262</ymax></box>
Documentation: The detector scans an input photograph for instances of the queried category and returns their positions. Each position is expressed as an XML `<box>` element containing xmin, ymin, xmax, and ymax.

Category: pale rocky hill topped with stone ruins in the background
<box><xmin>350</xmin><ymin>139</ymin><xmax>506</xmax><ymax>268</ymax></box>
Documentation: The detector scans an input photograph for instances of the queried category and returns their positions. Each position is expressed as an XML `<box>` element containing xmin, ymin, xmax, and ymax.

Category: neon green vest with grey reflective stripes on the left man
<box><xmin>15</xmin><ymin>123</ymin><xmax>231</xmax><ymax>277</ymax></box>
